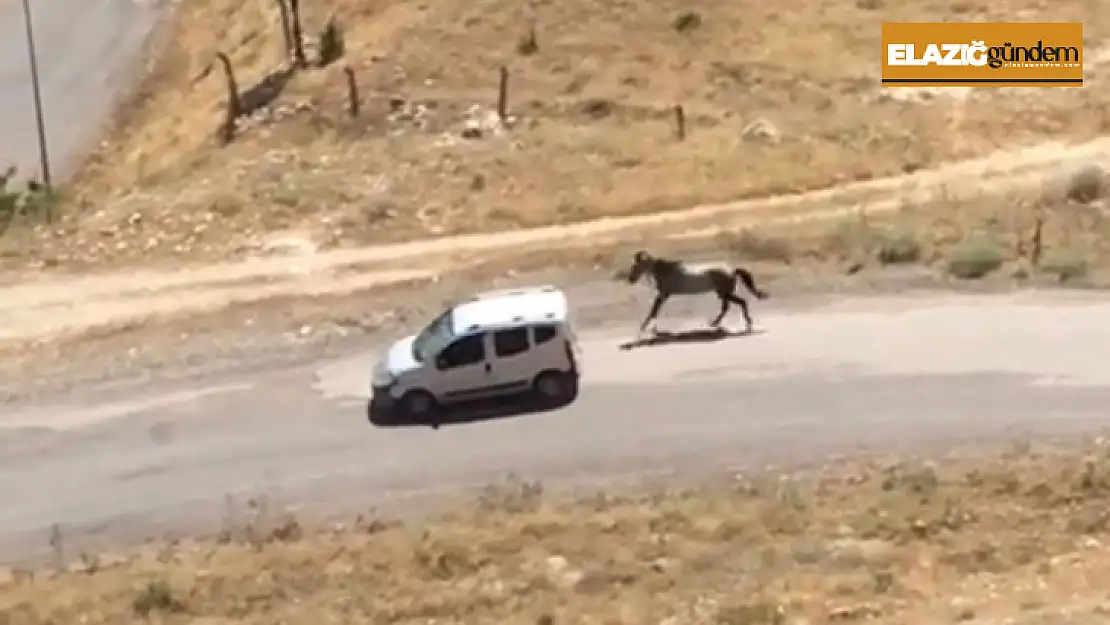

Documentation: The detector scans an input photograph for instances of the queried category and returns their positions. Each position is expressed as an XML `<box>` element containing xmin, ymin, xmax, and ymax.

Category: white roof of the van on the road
<box><xmin>451</xmin><ymin>285</ymin><xmax>568</xmax><ymax>334</ymax></box>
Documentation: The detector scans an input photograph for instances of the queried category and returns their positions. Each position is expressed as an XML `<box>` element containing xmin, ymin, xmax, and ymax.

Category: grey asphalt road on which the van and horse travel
<box><xmin>0</xmin><ymin>293</ymin><xmax>1110</xmax><ymax>560</ymax></box>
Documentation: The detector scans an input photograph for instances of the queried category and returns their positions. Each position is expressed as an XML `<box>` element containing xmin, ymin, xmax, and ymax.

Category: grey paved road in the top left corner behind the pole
<box><xmin>0</xmin><ymin>0</ymin><xmax>165</xmax><ymax>181</ymax></box>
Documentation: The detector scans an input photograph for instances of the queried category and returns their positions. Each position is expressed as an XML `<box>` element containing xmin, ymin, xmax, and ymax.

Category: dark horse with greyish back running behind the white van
<box><xmin>628</xmin><ymin>250</ymin><xmax>768</xmax><ymax>333</ymax></box>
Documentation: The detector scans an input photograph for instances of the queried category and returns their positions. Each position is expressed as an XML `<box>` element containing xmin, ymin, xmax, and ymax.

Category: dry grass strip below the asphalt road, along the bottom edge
<box><xmin>10</xmin><ymin>443</ymin><xmax>1110</xmax><ymax>625</ymax></box>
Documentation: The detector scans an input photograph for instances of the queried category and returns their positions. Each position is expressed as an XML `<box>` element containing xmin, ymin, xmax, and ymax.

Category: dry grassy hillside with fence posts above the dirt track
<box><xmin>0</xmin><ymin>0</ymin><xmax>1110</xmax><ymax>266</ymax></box>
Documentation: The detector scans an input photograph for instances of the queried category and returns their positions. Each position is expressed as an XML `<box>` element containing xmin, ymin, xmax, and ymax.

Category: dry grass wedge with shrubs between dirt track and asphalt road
<box><xmin>701</xmin><ymin>173</ymin><xmax>1110</xmax><ymax>282</ymax></box>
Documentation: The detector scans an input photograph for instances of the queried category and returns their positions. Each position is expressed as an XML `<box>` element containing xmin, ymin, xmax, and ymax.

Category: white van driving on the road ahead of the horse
<box><xmin>371</xmin><ymin>286</ymin><xmax>579</xmax><ymax>419</ymax></box>
